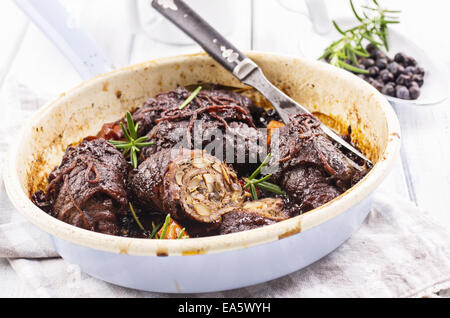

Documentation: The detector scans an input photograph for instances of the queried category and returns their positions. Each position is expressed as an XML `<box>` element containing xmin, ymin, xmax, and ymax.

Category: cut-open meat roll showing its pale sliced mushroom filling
<box><xmin>132</xmin><ymin>149</ymin><xmax>244</xmax><ymax>223</ymax></box>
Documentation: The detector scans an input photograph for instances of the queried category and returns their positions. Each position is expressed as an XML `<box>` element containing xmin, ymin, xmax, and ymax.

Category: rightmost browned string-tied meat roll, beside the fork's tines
<box><xmin>272</xmin><ymin>114</ymin><xmax>364</xmax><ymax>215</ymax></box>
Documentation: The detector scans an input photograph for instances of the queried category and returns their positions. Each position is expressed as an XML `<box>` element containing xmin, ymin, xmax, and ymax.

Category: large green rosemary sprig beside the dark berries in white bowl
<box><xmin>319</xmin><ymin>0</ymin><xmax>400</xmax><ymax>74</ymax></box>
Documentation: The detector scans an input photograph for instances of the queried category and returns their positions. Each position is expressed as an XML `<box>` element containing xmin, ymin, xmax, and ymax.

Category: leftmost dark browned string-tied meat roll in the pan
<box><xmin>36</xmin><ymin>139</ymin><xmax>128</xmax><ymax>235</ymax></box>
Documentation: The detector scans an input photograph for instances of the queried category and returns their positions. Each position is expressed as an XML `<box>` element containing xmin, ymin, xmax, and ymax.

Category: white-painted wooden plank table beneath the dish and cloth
<box><xmin>0</xmin><ymin>0</ymin><xmax>450</xmax><ymax>297</ymax></box>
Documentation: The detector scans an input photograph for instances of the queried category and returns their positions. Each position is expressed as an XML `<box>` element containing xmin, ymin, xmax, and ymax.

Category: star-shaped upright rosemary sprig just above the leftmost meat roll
<box><xmin>109</xmin><ymin>112</ymin><xmax>154</xmax><ymax>169</ymax></box>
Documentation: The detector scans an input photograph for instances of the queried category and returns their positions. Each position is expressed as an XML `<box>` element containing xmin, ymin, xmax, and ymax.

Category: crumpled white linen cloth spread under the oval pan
<box><xmin>0</xmin><ymin>78</ymin><xmax>450</xmax><ymax>298</ymax></box>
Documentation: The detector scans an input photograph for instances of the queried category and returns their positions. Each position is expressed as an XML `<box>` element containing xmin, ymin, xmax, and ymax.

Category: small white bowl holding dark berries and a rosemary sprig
<box><xmin>319</xmin><ymin>1</ymin><xmax>449</xmax><ymax>105</ymax></box>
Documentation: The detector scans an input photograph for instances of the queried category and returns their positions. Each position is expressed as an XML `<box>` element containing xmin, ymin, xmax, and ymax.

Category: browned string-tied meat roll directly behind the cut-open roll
<box><xmin>142</xmin><ymin>88</ymin><xmax>266</xmax><ymax>173</ymax></box>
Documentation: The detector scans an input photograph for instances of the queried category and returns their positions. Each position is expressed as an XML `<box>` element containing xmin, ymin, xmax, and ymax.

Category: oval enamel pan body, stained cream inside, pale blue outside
<box><xmin>5</xmin><ymin>52</ymin><xmax>400</xmax><ymax>293</ymax></box>
